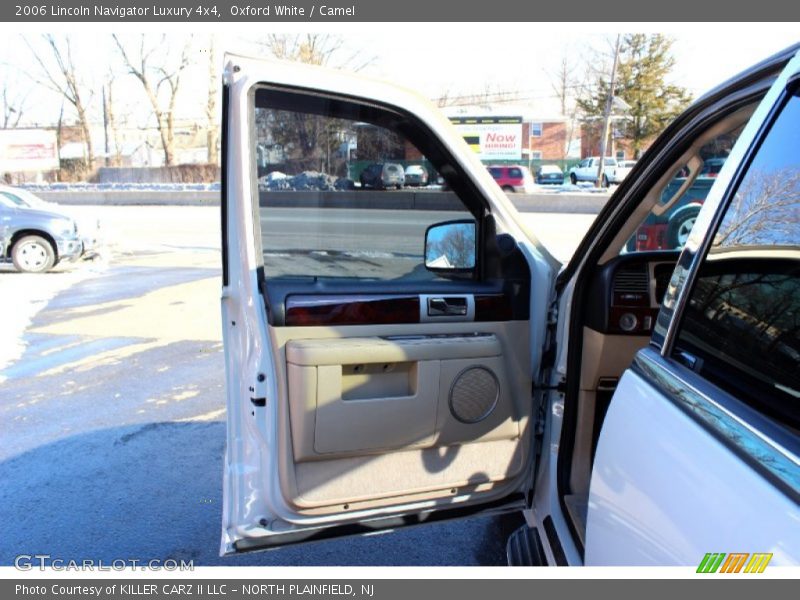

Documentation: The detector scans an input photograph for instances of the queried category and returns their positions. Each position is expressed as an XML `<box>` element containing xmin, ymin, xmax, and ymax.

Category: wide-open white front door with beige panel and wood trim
<box><xmin>221</xmin><ymin>56</ymin><xmax>558</xmax><ymax>554</ymax></box>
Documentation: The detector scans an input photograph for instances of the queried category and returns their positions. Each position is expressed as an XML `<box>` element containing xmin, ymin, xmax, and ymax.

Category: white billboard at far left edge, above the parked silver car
<box><xmin>0</xmin><ymin>129</ymin><xmax>59</xmax><ymax>173</ymax></box>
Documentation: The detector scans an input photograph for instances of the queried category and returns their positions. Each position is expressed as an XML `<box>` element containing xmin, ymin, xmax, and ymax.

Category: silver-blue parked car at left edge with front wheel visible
<box><xmin>0</xmin><ymin>192</ymin><xmax>83</xmax><ymax>273</ymax></box>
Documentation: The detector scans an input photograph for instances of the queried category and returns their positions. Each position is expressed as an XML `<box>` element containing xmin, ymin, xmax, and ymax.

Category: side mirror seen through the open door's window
<box><xmin>425</xmin><ymin>220</ymin><xmax>476</xmax><ymax>273</ymax></box>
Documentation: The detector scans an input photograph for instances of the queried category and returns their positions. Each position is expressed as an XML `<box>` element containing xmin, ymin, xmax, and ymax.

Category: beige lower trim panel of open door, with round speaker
<box><xmin>272</xmin><ymin>321</ymin><xmax>531</xmax><ymax>514</ymax></box>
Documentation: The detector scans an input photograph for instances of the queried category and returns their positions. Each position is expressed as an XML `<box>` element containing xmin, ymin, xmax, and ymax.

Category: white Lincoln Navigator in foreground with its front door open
<box><xmin>221</xmin><ymin>45</ymin><xmax>800</xmax><ymax>570</ymax></box>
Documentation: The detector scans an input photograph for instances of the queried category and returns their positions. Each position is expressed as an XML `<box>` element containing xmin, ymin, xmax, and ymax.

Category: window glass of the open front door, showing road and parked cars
<box><xmin>253</xmin><ymin>89</ymin><xmax>472</xmax><ymax>280</ymax></box>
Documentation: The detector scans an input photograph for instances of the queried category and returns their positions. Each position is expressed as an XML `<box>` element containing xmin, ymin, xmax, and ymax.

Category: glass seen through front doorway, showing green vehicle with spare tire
<box><xmin>625</xmin><ymin>125</ymin><xmax>744</xmax><ymax>252</ymax></box>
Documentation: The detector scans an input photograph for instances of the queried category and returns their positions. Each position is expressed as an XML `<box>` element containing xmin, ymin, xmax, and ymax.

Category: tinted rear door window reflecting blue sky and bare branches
<box><xmin>675</xmin><ymin>89</ymin><xmax>800</xmax><ymax>429</ymax></box>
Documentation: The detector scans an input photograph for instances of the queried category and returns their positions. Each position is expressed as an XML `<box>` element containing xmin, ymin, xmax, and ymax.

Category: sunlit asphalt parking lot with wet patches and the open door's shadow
<box><xmin>0</xmin><ymin>206</ymin><xmax>593</xmax><ymax>565</ymax></box>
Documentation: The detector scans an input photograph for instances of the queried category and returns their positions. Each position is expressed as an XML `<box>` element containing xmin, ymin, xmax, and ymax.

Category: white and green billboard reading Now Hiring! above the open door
<box><xmin>450</xmin><ymin>117</ymin><xmax>522</xmax><ymax>161</ymax></box>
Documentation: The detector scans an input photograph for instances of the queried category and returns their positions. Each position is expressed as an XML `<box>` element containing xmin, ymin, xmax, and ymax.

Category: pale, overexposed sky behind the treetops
<box><xmin>0</xmin><ymin>22</ymin><xmax>800</xmax><ymax>130</ymax></box>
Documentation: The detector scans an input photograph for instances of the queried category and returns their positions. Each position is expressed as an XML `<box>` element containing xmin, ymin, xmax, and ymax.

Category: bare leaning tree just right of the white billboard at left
<box><xmin>25</xmin><ymin>33</ymin><xmax>94</xmax><ymax>169</ymax></box>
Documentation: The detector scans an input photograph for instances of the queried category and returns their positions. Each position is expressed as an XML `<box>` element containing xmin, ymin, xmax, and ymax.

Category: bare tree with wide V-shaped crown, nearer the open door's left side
<box><xmin>112</xmin><ymin>34</ymin><xmax>192</xmax><ymax>166</ymax></box>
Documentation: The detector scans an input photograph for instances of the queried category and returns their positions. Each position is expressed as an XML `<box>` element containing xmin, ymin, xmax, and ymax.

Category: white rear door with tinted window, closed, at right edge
<box><xmin>585</xmin><ymin>59</ymin><xmax>800</xmax><ymax>571</ymax></box>
